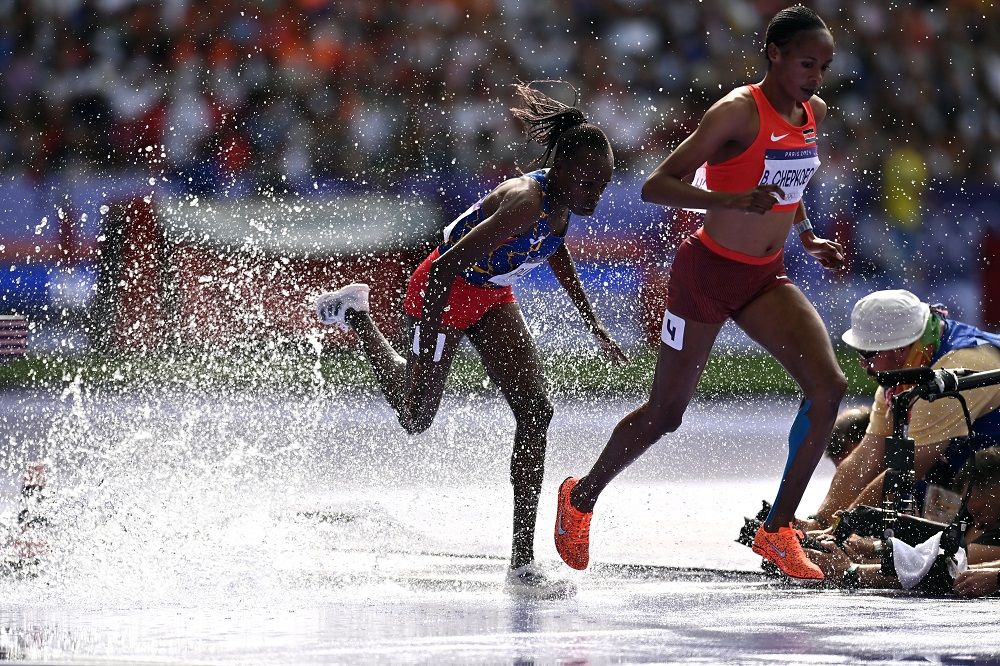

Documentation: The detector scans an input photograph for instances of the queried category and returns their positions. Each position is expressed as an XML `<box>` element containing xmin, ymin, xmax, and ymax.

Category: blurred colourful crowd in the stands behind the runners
<box><xmin>0</xmin><ymin>0</ymin><xmax>1000</xmax><ymax>316</ymax></box>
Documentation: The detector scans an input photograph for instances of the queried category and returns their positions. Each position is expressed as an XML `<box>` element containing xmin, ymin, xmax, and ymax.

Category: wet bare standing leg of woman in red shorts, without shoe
<box><xmin>468</xmin><ymin>303</ymin><xmax>553</xmax><ymax>569</ymax></box>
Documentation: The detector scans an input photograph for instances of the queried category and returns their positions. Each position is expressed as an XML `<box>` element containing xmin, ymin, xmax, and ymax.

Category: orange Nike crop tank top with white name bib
<box><xmin>705</xmin><ymin>83</ymin><xmax>819</xmax><ymax>210</ymax></box>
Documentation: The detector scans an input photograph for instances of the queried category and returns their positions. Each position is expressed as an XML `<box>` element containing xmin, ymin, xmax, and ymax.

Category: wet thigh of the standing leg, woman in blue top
<box><xmin>467</xmin><ymin>303</ymin><xmax>547</xmax><ymax>405</ymax></box>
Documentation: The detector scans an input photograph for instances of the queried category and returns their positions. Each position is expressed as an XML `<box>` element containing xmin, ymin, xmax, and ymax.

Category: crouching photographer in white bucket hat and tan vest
<box><xmin>800</xmin><ymin>289</ymin><xmax>1000</xmax><ymax>529</ymax></box>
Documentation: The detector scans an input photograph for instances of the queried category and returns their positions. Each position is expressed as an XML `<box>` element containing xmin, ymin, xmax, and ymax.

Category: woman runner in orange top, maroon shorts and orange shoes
<box><xmin>555</xmin><ymin>6</ymin><xmax>846</xmax><ymax>580</ymax></box>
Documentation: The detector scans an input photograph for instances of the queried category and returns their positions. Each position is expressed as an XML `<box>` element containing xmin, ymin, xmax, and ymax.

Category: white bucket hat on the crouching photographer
<box><xmin>840</xmin><ymin>289</ymin><xmax>931</xmax><ymax>351</ymax></box>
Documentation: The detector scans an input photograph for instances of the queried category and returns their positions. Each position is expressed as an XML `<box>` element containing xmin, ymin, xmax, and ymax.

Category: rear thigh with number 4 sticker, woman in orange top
<box><xmin>649</xmin><ymin>311</ymin><xmax>724</xmax><ymax>411</ymax></box>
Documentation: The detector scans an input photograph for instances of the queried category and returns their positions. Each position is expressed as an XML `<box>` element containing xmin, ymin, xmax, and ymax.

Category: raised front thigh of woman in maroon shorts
<box><xmin>733</xmin><ymin>284</ymin><xmax>840</xmax><ymax>390</ymax></box>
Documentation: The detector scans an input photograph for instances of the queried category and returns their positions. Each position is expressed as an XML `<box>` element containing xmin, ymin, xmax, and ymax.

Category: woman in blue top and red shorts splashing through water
<box><xmin>317</xmin><ymin>84</ymin><xmax>626</xmax><ymax>597</ymax></box>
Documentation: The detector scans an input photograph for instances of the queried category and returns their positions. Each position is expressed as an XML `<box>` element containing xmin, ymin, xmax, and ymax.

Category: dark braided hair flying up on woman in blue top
<box><xmin>511</xmin><ymin>80</ymin><xmax>611</xmax><ymax>168</ymax></box>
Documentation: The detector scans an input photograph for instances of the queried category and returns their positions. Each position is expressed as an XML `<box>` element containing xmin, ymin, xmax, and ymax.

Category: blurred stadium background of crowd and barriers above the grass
<box><xmin>0</xmin><ymin>0</ymin><xmax>1000</xmax><ymax>353</ymax></box>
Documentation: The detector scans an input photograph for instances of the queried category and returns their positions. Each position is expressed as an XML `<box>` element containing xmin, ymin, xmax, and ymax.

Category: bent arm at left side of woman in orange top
<box><xmin>642</xmin><ymin>98</ymin><xmax>784</xmax><ymax>214</ymax></box>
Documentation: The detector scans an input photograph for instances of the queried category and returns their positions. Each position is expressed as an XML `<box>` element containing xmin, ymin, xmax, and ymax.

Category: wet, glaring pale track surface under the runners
<box><xmin>0</xmin><ymin>393</ymin><xmax>1000</xmax><ymax>664</ymax></box>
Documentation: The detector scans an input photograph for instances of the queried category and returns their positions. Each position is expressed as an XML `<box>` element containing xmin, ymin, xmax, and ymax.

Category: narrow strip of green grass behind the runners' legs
<box><xmin>0</xmin><ymin>347</ymin><xmax>875</xmax><ymax>397</ymax></box>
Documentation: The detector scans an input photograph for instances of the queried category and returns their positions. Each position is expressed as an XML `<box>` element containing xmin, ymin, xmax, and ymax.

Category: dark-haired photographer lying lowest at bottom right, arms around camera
<box><xmin>809</xmin><ymin>447</ymin><xmax>1000</xmax><ymax>597</ymax></box>
